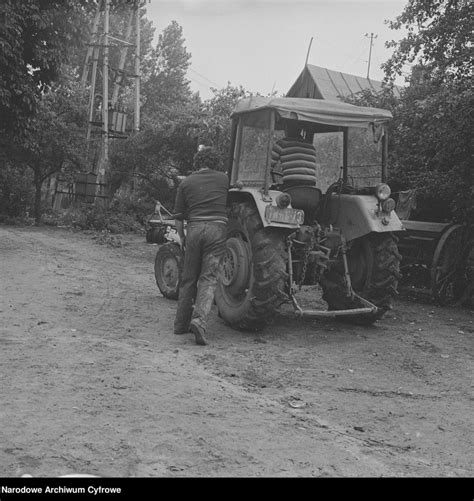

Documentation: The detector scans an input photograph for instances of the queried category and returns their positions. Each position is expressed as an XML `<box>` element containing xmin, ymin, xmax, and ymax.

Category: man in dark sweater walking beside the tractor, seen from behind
<box><xmin>174</xmin><ymin>147</ymin><xmax>229</xmax><ymax>345</ymax></box>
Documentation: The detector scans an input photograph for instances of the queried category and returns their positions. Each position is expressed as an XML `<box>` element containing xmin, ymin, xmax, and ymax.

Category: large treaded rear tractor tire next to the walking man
<box><xmin>216</xmin><ymin>202</ymin><xmax>288</xmax><ymax>331</ymax></box>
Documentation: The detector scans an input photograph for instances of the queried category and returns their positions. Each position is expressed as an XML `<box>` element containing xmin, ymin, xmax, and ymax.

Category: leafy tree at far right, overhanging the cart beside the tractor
<box><xmin>378</xmin><ymin>0</ymin><xmax>474</xmax><ymax>221</ymax></box>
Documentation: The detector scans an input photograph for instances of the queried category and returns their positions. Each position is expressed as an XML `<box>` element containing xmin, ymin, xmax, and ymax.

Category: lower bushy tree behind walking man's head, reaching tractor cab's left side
<box><xmin>110</xmin><ymin>80</ymin><xmax>249</xmax><ymax>203</ymax></box>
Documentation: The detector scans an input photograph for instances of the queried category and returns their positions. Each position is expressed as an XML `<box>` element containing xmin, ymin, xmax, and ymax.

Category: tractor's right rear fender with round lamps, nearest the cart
<box><xmin>323</xmin><ymin>194</ymin><xmax>404</xmax><ymax>241</ymax></box>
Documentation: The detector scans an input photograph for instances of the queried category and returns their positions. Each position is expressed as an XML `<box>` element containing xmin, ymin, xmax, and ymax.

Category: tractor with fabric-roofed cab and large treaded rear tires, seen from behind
<box><xmin>155</xmin><ymin>97</ymin><xmax>403</xmax><ymax>330</ymax></box>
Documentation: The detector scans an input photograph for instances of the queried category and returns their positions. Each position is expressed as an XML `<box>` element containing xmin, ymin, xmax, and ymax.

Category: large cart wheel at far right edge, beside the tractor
<box><xmin>431</xmin><ymin>224</ymin><xmax>468</xmax><ymax>306</ymax></box>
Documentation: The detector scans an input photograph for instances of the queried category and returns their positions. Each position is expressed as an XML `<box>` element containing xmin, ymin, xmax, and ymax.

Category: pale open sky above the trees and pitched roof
<box><xmin>146</xmin><ymin>0</ymin><xmax>407</xmax><ymax>99</ymax></box>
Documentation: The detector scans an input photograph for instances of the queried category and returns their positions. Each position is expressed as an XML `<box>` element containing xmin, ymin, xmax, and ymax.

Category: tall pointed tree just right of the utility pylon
<box><xmin>109</xmin><ymin>21</ymin><xmax>201</xmax><ymax>205</ymax></box>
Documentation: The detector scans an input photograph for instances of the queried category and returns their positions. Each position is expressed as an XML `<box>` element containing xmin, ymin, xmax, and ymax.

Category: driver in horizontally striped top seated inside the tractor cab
<box><xmin>271</xmin><ymin>120</ymin><xmax>317</xmax><ymax>187</ymax></box>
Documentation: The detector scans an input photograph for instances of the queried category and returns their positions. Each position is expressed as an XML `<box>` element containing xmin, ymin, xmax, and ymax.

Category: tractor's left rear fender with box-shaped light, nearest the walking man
<box><xmin>227</xmin><ymin>187</ymin><xmax>304</xmax><ymax>229</ymax></box>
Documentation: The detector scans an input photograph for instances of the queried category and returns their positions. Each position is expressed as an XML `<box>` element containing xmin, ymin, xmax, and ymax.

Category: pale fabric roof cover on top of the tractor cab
<box><xmin>233</xmin><ymin>96</ymin><xmax>392</xmax><ymax>127</ymax></box>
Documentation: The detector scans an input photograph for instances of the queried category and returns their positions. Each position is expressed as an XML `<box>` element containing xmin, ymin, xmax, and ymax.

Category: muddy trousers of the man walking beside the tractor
<box><xmin>174</xmin><ymin>222</ymin><xmax>227</xmax><ymax>334</ymax></box>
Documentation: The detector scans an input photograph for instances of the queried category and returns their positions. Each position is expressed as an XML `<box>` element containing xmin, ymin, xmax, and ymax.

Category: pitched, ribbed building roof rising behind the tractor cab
<box><xmin>286</xmin><ymin>64</ymin><xmax>400</xmax><ymax>101</ymax></box>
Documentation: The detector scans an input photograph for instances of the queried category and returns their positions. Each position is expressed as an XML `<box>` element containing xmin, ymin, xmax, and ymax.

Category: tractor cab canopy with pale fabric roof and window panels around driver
<box><xmin>228</xmin><ymin>96</ymin><xmax>393</xmax><ymax>192</ymax></box>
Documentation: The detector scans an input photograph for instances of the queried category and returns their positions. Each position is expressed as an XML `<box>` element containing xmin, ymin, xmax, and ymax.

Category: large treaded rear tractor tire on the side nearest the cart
<box><xmin>321</xmin><ymin>233</ymin><xmax>402</xmax><ymax>325</ymax></box>
